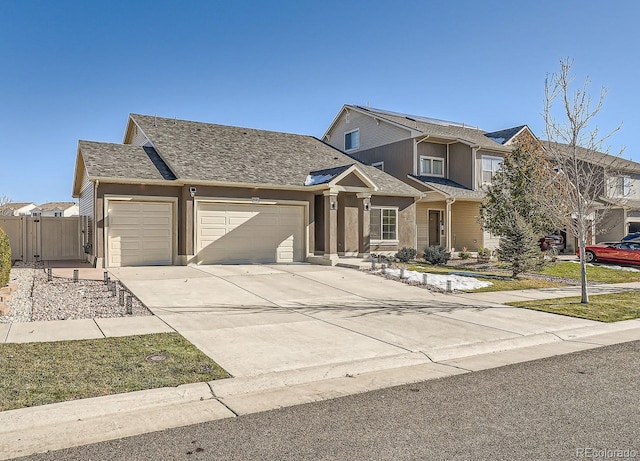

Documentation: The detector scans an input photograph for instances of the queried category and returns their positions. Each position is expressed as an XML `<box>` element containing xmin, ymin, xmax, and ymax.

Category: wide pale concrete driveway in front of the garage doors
<box><xmin>111</xmin><ymin>264</ymin><xmax>597</xmax><ymax>377</ymax></box>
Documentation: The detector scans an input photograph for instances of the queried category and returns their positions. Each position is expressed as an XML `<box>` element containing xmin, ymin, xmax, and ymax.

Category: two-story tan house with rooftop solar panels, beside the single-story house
<box><xmin>323</xmin><ymin>105</ymin><xmax>540</xmax><ymax>253</ymax></box>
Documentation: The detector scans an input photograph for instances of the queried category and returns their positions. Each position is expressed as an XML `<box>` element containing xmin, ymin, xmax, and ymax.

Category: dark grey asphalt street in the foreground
<box><xmin>20</xmin><ymin>341</ymin><xmax>640</xmax><ymax>461</ymax></box>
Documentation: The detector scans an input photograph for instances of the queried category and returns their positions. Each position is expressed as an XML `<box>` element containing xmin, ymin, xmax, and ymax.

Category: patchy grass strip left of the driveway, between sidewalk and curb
<box><xmin>0</xmin><ymin>333</ymin><xmax>229</xmax><ymax>411</ymax></box>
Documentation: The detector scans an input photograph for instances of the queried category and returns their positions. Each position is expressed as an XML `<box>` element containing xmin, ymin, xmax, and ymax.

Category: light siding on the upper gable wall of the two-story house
<box><xmin>327</xmin><ymin>110</ymin><xmax>410</xmax><ymax>154</ymax></box>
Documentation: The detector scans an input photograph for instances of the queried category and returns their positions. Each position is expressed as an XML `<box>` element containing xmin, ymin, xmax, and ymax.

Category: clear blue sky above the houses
<box><xmin>0</xmin><ymin>0</ymin><xmax>640</xmax><ymax>203</ymax></box>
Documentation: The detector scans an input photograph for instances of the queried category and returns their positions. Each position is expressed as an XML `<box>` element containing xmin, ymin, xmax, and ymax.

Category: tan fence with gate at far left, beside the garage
<box><xmin>0</xmin><ymin>216</ymin><xmax>87</xmax><ymax>262</ymax></box>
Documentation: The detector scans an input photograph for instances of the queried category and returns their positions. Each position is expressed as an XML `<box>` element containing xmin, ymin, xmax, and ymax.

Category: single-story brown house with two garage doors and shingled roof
<box><xmin>73</xmin><ymin>114</ymin><xmax>420</xmax><ymax>267</ymax></box>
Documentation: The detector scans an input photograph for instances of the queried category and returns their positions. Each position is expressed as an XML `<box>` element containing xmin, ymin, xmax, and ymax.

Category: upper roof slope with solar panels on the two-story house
<box><xmin>346</xmin><ymin>106</ymin><xmax>511</xmax><ymax>152</ymax></box>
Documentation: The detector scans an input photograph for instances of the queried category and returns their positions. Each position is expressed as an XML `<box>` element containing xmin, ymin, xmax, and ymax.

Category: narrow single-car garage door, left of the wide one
<box><xmin>107</xmin><ymin>200</ymin><xmax>173</xmax><ymax>267</ymax></box>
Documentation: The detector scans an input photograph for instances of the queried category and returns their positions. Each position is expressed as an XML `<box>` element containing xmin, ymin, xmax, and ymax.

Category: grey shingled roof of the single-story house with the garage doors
<box><xmin>127</xmin><ymin>114</ymin><xmax>420</xmax><ymax>196</ymax></box>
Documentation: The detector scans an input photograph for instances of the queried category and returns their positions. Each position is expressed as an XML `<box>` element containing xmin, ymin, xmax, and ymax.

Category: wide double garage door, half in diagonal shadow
<box><xmin>196</xmin><ymin>202</ymin><xmax>305</xmax><ymax>264</ymax></box>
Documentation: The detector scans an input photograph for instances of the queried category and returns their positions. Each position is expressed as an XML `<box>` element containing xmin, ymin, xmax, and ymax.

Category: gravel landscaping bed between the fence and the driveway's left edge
<box><xmin>0</xmin><ymin>263</ymin><xmax>153</xmax><ymax>323</ymax></box>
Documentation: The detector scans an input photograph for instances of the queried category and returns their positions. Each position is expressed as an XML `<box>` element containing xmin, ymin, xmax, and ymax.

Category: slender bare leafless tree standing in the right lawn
<box><xmin>543</xmin><ymin>59</ymin><xmax>622</xmax><ymax>303</ymax></box>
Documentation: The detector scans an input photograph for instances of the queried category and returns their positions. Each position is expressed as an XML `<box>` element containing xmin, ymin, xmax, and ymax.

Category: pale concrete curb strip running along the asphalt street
<box><xmin>0</xmin><ymin>320</ymin><xmax>640</xmax><ymax>460</ymax></box>
